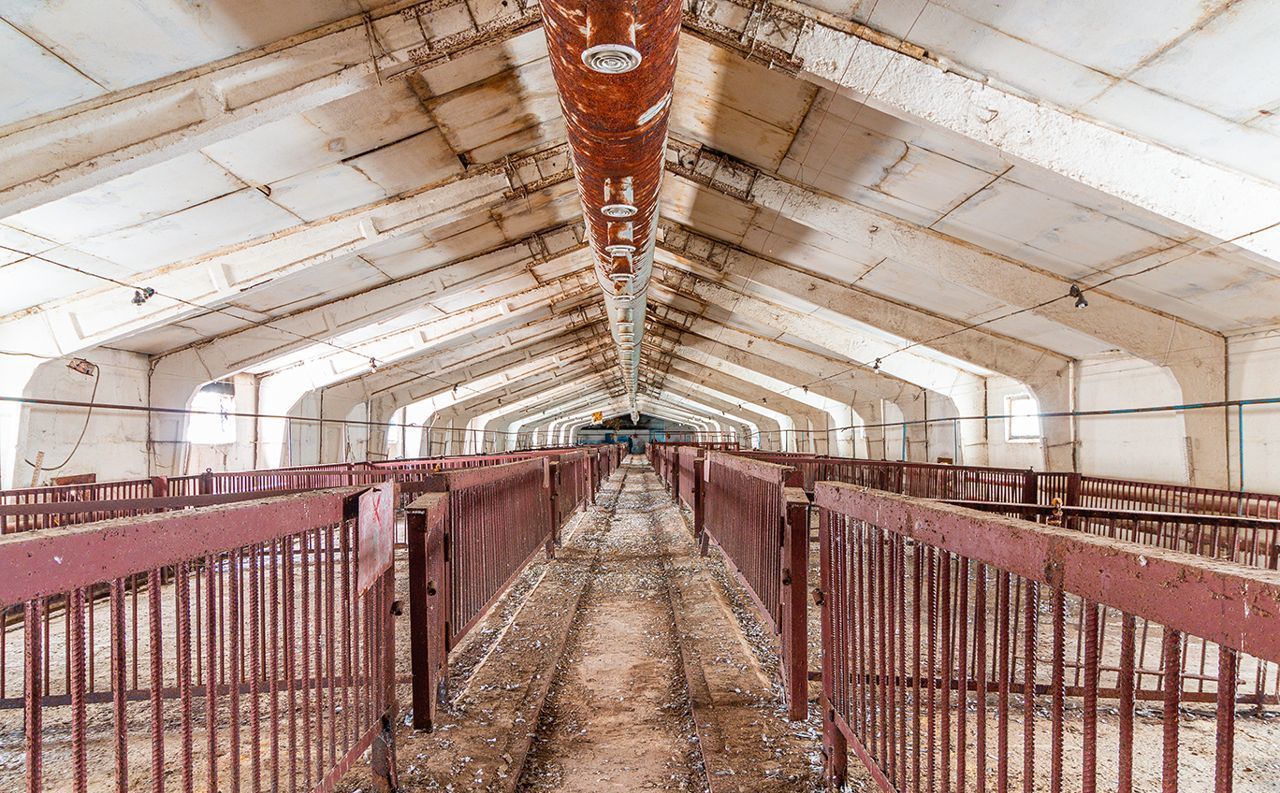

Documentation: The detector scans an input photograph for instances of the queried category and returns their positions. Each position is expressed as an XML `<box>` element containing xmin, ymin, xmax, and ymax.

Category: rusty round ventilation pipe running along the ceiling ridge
<box><xmin>541</xmin><ymin>0</ymin><xmax>681</xmax><ymax>420</ymax></box>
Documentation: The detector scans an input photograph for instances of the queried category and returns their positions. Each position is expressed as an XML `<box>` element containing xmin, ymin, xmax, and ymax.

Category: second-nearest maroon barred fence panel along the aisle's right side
<box><xmin>699</xmin><ymin>451</ymin><xmax>809</xmax><ymax>719</ymax></box>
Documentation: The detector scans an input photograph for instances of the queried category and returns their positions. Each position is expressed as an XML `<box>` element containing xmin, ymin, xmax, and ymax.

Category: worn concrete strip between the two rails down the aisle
<box><xmin>521</xmin><ymin>457</ymin><xmax>703</xmax><ymax>792</ymax></box>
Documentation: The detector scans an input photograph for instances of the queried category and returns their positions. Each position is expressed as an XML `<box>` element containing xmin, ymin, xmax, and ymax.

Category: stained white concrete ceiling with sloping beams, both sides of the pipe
<box><xmin>0</xmin><ymin>0</ymin><xmax>1280</xmax><ymax>434</ymax></box>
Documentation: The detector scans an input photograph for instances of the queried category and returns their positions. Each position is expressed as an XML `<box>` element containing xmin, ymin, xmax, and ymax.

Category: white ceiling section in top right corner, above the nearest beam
<box><xmin>836</xmin><ymin>0</ymin><xmax>1280</xmax><ymax>189</ymax></box>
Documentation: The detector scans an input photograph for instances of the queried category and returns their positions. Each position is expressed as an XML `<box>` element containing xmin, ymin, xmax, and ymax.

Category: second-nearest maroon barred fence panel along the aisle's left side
<box><xmin>406</xmin><ymin>459</ymin><xmax>556</xmax><ymax>729</ymax></box>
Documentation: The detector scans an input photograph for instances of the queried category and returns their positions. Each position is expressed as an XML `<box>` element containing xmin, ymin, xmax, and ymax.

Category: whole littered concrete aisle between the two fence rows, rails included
<box><xmin>353</xmin><ymin>455</ymin><xmax>822</xmax><ymax>792</ymax></box>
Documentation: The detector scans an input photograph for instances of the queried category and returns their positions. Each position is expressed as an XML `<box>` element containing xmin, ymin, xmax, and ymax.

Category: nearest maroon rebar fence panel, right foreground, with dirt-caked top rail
<box><xmin>815</xmin><ymin>482</ymin><xmax>1280</xmax><ymax>793</ymax></box>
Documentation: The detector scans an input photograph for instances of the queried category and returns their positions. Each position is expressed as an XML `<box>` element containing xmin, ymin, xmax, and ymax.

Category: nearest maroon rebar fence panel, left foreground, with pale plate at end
<box><xmin>0</xmin><ymin>485</ymin><xmax>396</xmax><ymax>790</ymax></box>
